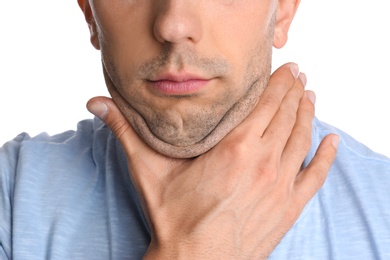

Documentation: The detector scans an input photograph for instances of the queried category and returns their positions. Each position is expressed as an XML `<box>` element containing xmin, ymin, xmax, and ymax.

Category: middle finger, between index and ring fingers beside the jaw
<box><xmin>262</xmin><ymin>73</ymin><xmax>306</xmax><ymax>156</ymax></box>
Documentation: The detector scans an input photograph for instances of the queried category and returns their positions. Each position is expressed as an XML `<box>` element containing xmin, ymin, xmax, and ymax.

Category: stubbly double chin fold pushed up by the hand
<box><xmin>104</xmin><ymin>64</ymin><xmax>265</xmax><ymax>158</ymax></box>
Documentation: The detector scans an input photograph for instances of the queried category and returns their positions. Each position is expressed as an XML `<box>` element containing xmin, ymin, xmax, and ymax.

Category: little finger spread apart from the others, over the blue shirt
<box><xmin>294</xmin><ymin>134</ymin><xmax>340</xmax><ymax>203</ymax></box>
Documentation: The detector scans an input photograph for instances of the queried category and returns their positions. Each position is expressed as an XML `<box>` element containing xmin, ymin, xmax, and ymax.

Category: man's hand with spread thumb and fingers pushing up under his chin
<box><xmin>87</xmin><ymin>64</ymin><xmax>338</xmax><ymax>259</ymax></box>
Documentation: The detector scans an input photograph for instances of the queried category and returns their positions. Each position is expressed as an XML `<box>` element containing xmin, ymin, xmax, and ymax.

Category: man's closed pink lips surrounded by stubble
<box><xmin>148</xmin><ymin>73</ymin><xmax>211</xmax><ymax>96</ymax></box>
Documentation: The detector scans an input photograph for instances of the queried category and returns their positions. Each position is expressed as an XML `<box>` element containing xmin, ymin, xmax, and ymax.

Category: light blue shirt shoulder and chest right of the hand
<box><xmin>273</xmin><ymin>119</ymin><xmax>390</xmax><ymax>259</ymax></box>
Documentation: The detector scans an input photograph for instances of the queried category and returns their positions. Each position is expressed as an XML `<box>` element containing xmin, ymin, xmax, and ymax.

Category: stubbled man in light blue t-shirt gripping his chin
<box><xmin>0</xmin><ymin>0</ymin><xmax>390</xmax><ymax>259</ymax></box>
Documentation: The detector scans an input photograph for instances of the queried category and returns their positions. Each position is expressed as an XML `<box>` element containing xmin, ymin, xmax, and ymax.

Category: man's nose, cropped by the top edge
<box><xmin>153</xmin><ymin>0</ymin><xmax>202</xmax><ymax>43</ymax></box>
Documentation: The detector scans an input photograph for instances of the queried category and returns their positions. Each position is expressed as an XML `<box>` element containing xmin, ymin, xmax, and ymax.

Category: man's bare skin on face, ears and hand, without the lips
<box><xmin>79</xmin><ymin>0</ymin><xmax>339</xmax><ymax>259</ymax></box>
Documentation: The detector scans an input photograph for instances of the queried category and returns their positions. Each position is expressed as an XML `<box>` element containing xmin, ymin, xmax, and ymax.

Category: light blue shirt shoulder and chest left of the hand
<box><xmin>0</xmin><ymin>119</ymin><xmax>147</xmax><ymax>259</ymax></box>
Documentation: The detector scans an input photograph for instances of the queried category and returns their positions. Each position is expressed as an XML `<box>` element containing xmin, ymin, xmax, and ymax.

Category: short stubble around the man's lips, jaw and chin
<box><xmin>101</xmin><ymin>19</ymin><xmax>273</xmax><ymax>158</ymax></box>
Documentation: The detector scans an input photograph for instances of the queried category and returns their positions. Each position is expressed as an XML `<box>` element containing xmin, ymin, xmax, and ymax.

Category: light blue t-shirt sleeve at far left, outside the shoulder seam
<box><xmin>0</xmin><ymin>133</ymin><xmax>30</xmax><ymax>259</ymax></box>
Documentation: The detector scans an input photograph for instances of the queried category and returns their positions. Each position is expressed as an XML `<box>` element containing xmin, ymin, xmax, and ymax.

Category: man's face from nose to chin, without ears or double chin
<box><xmin>83</xmin><ymin>0</ymin><xmax>296</xmax><ymax>156</ymax></box>
